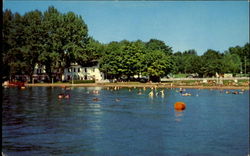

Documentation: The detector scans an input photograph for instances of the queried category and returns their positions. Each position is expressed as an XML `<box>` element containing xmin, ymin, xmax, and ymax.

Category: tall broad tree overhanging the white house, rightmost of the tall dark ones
<box><xmin>39</xmin><ymin>7</ymin><xmax>89</xmax><ymax>81</ymax></box>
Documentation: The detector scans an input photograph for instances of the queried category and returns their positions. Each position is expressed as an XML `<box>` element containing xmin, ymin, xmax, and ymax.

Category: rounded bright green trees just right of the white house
<box><xmin>100</xmin><ymin>40</ymin><xmax>174</xmax><ymax>81</ymax></box>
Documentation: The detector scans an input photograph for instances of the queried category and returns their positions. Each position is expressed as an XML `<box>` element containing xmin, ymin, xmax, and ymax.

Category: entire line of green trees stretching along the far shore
<box><xmin>2</xmin><ymin>7</ymin><xmax>250</xmax><ymax>81</ymax></box>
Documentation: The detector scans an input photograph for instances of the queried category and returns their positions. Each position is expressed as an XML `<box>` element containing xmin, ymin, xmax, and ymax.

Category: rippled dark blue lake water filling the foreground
<box><xmin>2</xmin><ymin>87</ymin><xmax>249</xmax><ymax>156</ymax></box>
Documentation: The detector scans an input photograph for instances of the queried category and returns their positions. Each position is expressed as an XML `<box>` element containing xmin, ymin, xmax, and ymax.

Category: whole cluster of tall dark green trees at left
<box><xmin>3</xmin><ymin>7</ymin><xmax>89</xmax><ymax>81</ymax></box>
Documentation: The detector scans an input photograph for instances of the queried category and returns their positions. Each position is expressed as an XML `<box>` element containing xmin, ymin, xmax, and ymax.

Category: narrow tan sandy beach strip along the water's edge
<box><xmin>25</xmin><ymin>83</ymin><xmax>249</xmax><ymax>90</ymax></box>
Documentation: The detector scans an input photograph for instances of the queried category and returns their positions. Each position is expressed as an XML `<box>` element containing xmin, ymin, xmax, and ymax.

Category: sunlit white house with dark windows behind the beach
<box><xmin>62</xmin><ymin>63</ymin><xmax>104</xmax><ymax>81</ymax></box>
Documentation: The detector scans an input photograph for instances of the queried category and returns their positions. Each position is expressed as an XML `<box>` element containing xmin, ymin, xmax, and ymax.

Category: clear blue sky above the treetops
<box><xmin>3</xmin><ymin>0</ymin><xmax>249</xmax><ymax>55</ymax></box>
